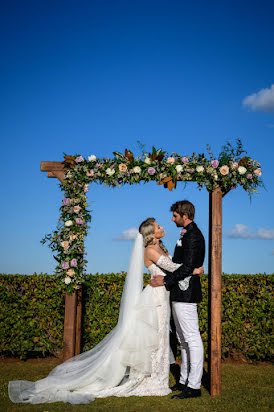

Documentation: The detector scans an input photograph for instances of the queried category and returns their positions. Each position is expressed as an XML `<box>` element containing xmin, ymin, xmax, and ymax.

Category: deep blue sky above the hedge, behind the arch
<box><xmin>0</xmin><ymin>0</ymin><xmax>274</xmax><ymax>274</ymax></box>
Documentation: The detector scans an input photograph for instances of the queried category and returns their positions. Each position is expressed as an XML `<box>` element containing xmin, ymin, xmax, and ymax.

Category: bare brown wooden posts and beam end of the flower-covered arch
<box><xmin>41</xmin><ymin>161</ymin><xmax>222</xmax><ymax>396</ymax></box>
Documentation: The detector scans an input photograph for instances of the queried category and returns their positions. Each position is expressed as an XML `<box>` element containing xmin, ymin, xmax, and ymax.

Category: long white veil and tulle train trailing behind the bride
<box><xmin>9</xmin><ymin>234</ymin><xmax>158</xmax><ymax>404</ymax></box>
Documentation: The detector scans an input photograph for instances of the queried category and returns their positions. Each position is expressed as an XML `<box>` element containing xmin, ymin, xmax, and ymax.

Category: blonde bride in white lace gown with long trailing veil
<box><xmin>9</xmin><ymin>218</ymin><xmax>203</xmax><ymax>404</ymax></box>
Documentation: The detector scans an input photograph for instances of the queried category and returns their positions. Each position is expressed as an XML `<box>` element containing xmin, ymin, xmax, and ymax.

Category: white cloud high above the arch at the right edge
<box><xmin>243</xmin><ymin>84</ymin><xmax>274</xmax><ymax>112</ymax></box>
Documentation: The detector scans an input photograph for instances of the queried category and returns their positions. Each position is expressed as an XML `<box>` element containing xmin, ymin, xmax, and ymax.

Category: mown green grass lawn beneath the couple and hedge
<box><xmin>0</xmin><ymin>360</ymin><xmax>274</xmax><ymax>412</ymax></box>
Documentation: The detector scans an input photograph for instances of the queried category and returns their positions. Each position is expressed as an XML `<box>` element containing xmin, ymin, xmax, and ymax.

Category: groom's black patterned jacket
<box><xmin>164</xmin><ymin>222</ymin><xmax>205</xmax><ymax>303</ymax></box>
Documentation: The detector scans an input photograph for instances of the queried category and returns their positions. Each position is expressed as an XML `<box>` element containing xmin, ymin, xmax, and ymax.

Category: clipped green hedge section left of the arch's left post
<box><xmin>0</xmin><ymin>273</ymin><xmax>64</xmax><ymax>358</ymax></box>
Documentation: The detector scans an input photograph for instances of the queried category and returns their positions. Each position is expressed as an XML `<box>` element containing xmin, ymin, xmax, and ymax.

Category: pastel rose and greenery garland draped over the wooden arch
<box><xmin>41</xmin><ymin>139</ymin><xmax>263</xmax><ymax>293</ymax></box>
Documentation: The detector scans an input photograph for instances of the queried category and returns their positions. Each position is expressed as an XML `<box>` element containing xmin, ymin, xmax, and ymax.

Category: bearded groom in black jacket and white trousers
<box><xmin>150</xmin><ymin>200</ymin><xmax>205</xmax><ymax>399</ymax></box>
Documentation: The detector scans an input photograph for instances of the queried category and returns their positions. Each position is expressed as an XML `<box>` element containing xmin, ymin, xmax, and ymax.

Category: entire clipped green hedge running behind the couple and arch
<box><xmin>0</xmin><ymin>273</ymin><xmax>274</xmax><ymax>361</ymax></box>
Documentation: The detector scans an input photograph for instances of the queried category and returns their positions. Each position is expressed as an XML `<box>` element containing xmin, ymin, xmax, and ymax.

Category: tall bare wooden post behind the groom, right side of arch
<box><xmin>208</xmin><ymin>187</ymin><xmax>222</xmax><ymax>396</ymax></box>
